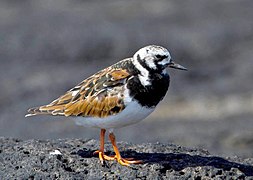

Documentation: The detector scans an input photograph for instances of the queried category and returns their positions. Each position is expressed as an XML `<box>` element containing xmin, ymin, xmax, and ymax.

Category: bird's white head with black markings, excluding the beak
<box><xmin>133</xmin><ymin>45</ymin><xmax>171</xmax><ymax>86</ymax></box>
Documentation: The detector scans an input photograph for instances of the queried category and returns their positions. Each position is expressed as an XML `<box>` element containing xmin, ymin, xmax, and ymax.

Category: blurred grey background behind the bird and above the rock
<box><xmin>0</xmin><ymin>0</ymin><xmax>253</xmax><ymax>157</ymax></box>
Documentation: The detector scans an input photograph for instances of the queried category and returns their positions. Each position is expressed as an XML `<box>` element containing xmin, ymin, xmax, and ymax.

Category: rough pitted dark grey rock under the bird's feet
<box><xmin>0</xmin><ymin>137</ymin><xmax>253</xmax><ymax>179</ymax></box>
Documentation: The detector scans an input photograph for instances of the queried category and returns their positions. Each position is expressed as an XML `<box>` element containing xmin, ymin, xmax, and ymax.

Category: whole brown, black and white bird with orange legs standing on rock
<box><xmin>26</xmin><ymin>45</ymin><xmax>187</xmax><ymax>166</ymax></box>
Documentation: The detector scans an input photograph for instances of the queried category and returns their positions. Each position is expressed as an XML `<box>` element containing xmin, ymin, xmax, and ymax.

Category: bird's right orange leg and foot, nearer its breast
<box><xmin>109</xmin><ymin>132</ymin><xmax>142</xmax><ymax>166</ymax></box>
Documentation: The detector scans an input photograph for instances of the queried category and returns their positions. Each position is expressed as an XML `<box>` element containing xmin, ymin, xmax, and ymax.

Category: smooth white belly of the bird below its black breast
<box><xmin>74</xmin><ymin>101</ymin><xmax>155</xmax><ymax>129</ymax></box>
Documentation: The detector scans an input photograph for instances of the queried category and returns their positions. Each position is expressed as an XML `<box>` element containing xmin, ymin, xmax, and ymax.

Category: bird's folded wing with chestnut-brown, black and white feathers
<box><xmin>26</xmin><ymin>67</ymin><xmax>130</xmax><ymax>117</ymax></box>
